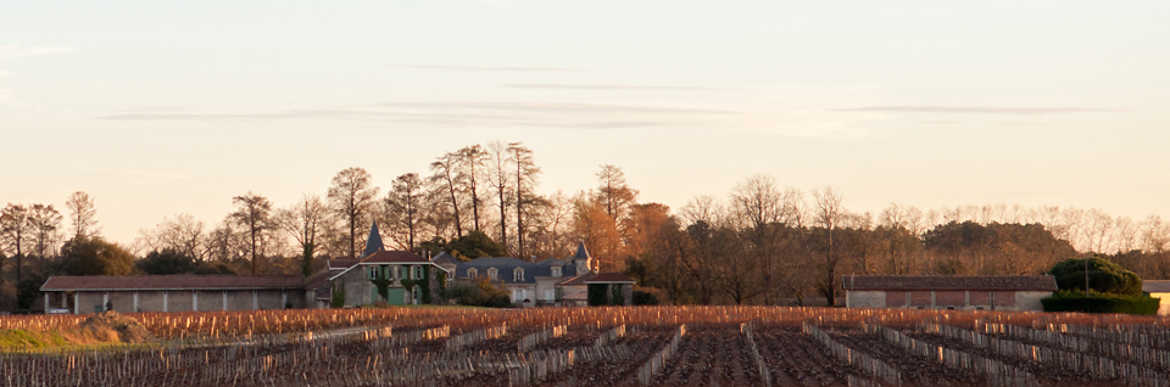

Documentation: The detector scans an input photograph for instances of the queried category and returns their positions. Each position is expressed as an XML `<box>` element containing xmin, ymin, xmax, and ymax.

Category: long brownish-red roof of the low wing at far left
<box><xmin>41</xmin><ymin>274</ymin><xmax>305</xmax><ymax>291</ymax></box>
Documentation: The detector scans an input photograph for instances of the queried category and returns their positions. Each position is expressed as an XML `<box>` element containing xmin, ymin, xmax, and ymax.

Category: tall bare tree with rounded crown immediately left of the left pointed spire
<box><xmin>329</xmin><ymin>167</ymin><xmax>378</xmax><ymax>257</ymax></box>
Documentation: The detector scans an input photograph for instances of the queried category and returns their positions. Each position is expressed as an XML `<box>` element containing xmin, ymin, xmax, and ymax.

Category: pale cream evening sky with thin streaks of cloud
<box><xmin>0</xmin><ymin>0</ymin><xmax>1170</xmax><ymax>243</ymax></box>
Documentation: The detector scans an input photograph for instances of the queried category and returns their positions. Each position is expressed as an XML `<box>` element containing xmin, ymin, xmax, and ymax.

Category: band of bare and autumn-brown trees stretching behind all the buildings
<box><xmin>0</xmin><ymin>143</ymin><xmax>1170</xmax><ymax>310</ymax></box>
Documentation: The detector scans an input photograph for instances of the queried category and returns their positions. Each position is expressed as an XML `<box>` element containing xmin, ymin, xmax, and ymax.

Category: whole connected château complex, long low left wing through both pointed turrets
<box><xmin>41</xmin><ymin>223</ymin><xmax>633</xmax><ymax>313</ymax></box>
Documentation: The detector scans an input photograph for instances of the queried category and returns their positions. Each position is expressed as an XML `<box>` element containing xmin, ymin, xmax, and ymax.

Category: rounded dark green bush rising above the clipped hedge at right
<box><xmin>1048</xmin><ymin>257</ymin><xmax>1142</xmax><ymax>296</ymax></box>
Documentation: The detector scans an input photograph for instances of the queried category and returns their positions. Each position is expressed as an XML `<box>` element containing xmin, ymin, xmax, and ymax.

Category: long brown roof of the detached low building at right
<box><xmin>841</xmin><ymin>276</ymin><xmax>1057</xmax><ymax>291</ymax></box>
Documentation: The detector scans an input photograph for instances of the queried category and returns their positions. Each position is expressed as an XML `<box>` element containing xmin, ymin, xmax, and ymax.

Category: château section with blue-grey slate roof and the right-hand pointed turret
<box><xmin>449</xmin><ymin>243</ymin><xmax>634</xmax><ymax>306</ymax></box>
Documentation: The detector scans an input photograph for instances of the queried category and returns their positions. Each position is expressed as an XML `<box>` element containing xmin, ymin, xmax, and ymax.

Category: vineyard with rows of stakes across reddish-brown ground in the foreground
<box><xmin>0</xmin><ymin>306</ymin><xmax>1170</xmax><ymax>386</ymax></box>
